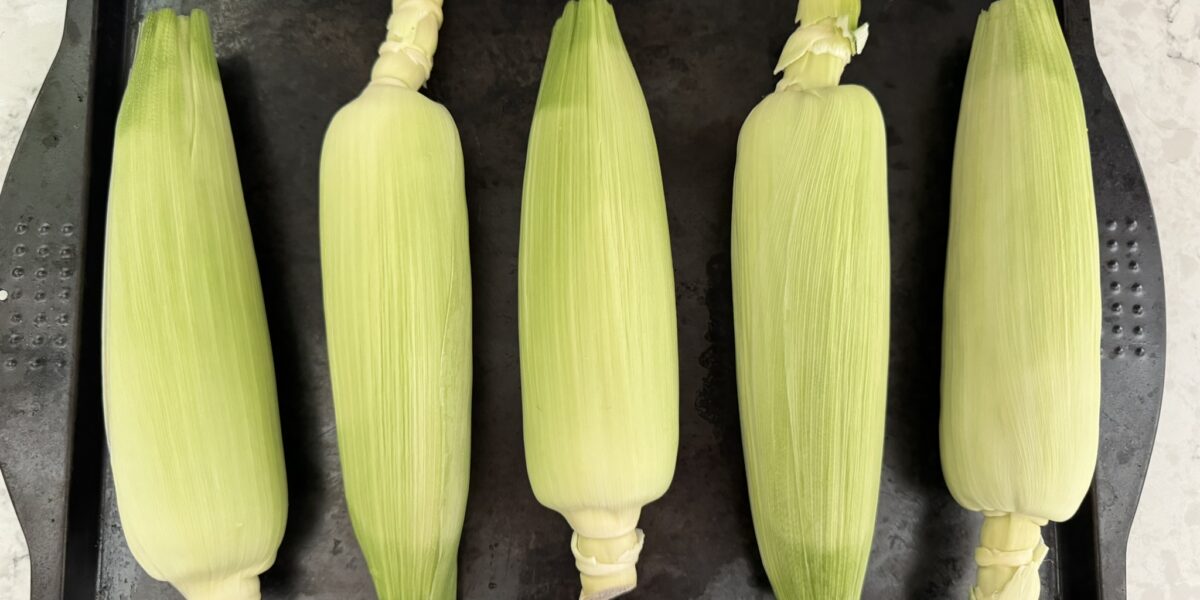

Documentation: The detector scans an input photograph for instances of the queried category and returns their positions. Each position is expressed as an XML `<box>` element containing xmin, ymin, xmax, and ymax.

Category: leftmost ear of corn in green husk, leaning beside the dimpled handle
<box><xmin>102</xmin><ymin>11</ymin><xmax>287</xmax><ymax>600</ymax></box>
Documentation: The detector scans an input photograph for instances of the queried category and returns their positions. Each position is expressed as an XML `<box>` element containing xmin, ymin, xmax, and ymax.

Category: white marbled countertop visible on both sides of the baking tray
<box><xmin>0</xmin><ymin>0</ymin><xmax>1200</xmax><ymax>600</ymax></box>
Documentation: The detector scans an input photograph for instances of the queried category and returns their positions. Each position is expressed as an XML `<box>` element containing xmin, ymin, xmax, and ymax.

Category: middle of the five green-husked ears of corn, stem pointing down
<box><xmin>520</xmin><ymin>0</ymin><xmax>679</xmax><ymax>599</ymax></box>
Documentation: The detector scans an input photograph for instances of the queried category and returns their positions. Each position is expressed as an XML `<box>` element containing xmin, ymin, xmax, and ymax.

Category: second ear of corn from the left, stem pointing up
<box><xmin>320</xmin><ymin>0</ymin><xmax>472</xmax><ymax>600</ymax></box>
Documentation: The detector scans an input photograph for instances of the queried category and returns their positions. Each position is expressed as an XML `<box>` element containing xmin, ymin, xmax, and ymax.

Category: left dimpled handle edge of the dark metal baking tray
<box><xmin>0</xmin><ymin>0</ymin><xmax>98</xmax><ymax>598</ymax></box>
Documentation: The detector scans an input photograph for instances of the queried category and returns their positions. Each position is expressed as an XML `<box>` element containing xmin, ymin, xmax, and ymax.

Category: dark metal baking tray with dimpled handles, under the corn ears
<box><xmin>0</xmin><ymin>0</ymin><xmax>1165</xmax><ymax>600</ymax></box>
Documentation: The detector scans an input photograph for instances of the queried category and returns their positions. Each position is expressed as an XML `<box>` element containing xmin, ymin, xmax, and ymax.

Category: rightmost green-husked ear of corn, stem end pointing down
<box><xmin>941</xmin><ymin>0</ymin><xmax>1100</xmax><ymax>600</ymax></box>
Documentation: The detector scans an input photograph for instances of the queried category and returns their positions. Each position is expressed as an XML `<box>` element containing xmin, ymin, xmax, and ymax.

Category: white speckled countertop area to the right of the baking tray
<box><xmin>1092</xmin><ymin>0</ymin><xmax>1200</xmax><ymax>600</ymax></box>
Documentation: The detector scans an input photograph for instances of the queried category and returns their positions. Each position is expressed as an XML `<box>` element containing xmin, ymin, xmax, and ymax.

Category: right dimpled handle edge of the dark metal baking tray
<box><xmin>1064</xmin><ymin>0</ymin><xmax>1166</xmax><ymax>600</ymax></box>
